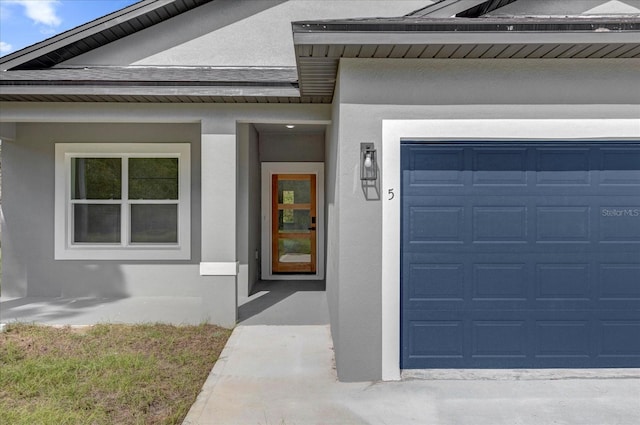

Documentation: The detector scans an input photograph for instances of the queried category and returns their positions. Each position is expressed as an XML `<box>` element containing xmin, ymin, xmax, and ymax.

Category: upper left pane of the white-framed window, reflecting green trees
<box><xmin>71</xmin><ymin>158</ymin><xmax>122</xmax><ymax>199</ymax></box>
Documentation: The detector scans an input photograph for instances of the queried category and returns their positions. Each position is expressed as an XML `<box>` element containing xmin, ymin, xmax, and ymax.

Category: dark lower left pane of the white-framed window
<box><xmin>73</xmin><ymin>204</ymin><xmax>120</xmax><ymax>243</ymax></box>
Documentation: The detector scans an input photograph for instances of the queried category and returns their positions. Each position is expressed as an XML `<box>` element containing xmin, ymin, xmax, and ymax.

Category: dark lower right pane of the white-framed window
<box><xmin>131</xmin><ymin>204</ymin><xmax>178</xmax><ymax>243</ymax></box>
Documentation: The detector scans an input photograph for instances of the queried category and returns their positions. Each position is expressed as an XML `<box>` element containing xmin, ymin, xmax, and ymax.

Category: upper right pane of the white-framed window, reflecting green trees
<box><xmin>129</xmin><ymin>158</ymin><xmax>178</xmax><ymax>199</ymax></box>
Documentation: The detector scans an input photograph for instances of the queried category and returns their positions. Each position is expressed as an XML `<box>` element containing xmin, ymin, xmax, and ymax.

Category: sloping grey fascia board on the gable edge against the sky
<box><xmin>0</xmin><ymin>0</ymin><xmax>174</xmax><ymax>71</ymax></box>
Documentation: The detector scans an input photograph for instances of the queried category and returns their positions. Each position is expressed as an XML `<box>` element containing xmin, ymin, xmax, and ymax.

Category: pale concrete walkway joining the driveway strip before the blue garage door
<box><xmin>184</xmin><ymin>325</ymin><xmax>640</xmax><ymax>425</ymax></box>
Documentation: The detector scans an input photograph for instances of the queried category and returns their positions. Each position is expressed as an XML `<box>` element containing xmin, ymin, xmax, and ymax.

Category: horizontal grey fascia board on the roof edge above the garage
<box><xmin>293</xmin><ymin>31</ymin><xmax>640</xmax><ymax>45</ymax></box>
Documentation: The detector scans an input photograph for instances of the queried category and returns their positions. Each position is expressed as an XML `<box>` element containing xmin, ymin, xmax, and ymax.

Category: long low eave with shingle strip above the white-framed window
<box><xmin>0</xmin><ymin>66</ymin><xmax>330</xmax><ymax>103</ymax></box>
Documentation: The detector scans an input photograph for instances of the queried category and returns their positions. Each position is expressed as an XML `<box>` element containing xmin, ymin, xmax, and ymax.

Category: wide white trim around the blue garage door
<box><xmin>380</xmin><ymin>119</ymin><xmax>640</xmax><ymax>381</ymax></box>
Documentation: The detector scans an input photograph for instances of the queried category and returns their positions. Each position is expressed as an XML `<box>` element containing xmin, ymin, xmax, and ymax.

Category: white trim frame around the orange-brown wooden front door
<box><xmin>260</xmin><ymin>162</ymin><xmax>324</xmax><ymax>280</ymax></box>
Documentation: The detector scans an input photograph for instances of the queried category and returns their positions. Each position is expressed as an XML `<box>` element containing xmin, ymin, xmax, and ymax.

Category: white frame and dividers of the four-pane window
<box><xmin>54</xmin><ymin>143</ymin><xmax>191</xmax><ymax>260</ymax></box>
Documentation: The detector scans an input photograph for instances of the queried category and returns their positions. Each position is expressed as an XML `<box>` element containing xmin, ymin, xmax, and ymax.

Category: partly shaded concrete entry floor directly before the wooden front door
<box><xmin>238</xmin><ymin>280</ymin><xmax>329</xmax><ymax>325</ymax></box>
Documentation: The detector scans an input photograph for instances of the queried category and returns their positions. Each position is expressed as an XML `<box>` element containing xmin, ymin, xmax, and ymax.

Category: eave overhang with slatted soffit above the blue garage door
<box><xmin>293</xmin><ymin>16</ymin><xmax>640</xmax><ymax>96</ymax></box>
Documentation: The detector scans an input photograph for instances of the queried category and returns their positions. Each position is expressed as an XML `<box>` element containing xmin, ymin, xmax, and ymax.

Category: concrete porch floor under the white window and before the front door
<box><xmin>0</xmin><ymin>281</ymin><xmax>329</xmax><ymax>326</ymax></box>
